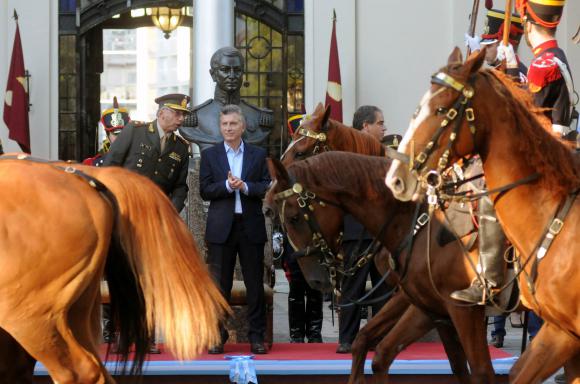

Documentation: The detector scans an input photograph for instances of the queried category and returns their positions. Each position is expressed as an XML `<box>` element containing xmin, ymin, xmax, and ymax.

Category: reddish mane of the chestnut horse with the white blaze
<box><xmin>479</xmin><ymin>70</ymin><xmax>580</xmax><ymax>198</ymax></box>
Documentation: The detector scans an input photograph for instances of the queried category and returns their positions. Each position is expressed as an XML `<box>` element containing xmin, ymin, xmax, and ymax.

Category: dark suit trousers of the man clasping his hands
<box><xmin>207</xmin><ymin>215</ymin><xmax>266</xmax><ymax>343</ymax></box>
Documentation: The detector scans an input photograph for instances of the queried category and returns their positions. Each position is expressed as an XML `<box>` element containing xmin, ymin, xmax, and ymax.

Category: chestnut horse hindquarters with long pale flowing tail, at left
<box><xmin>0</xmin><ymin>156</ymin><xmax>227</xmax><ymax>383</ymax></box>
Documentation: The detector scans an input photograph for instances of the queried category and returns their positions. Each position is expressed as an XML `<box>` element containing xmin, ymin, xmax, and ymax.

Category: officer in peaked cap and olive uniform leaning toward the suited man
<box><xmin>103</xmin><ymin>94</ymin><xmax>190</xmax><ymax>212</ymax></box>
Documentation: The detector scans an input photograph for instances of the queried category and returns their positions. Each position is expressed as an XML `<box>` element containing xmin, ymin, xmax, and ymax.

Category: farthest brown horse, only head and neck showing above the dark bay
<box><xmin>282</xmin><ymin>103</ymin><xmax>385</xmax><ymax>166</ymax></box>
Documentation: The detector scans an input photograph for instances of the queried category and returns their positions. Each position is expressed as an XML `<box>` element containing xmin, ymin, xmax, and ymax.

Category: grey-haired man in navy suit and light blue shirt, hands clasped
<box><xmin>199</xmin><ymin>104</ymin><xmax>270</xmax><ymax>354</ymax></box>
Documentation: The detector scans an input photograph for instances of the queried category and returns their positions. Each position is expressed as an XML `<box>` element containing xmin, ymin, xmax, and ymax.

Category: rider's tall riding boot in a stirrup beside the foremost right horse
<box><xmin>451</xmin><ymin>196</ymin><xmax>506</xmax><ymax>304</ymax></box>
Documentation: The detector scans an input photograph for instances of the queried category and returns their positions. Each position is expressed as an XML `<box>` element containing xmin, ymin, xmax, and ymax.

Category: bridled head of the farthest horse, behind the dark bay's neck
<box><xmin>282</xmin><ymin>103</ymin><xmax>330</xmax><ymax>166</ymax></box>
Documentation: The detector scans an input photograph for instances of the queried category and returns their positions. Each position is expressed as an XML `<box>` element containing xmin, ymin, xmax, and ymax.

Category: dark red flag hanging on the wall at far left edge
<box><xmin>4</xmin><ymin>11</ymin><xmax>30</xmax><ymax>153</ymax></box>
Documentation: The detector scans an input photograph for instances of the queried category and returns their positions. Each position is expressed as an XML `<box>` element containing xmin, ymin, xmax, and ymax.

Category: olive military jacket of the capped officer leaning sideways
<box><xmin>103</xmin><ymin>120</ymin><xmax>189</xmax><ymax>211</ymax></box>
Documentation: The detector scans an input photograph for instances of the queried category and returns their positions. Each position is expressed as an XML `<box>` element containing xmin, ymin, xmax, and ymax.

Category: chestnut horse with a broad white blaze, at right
<box><xmin>386</xmin><ymin>49</ymin><xmax>580</xmax><ymax>383</ymax></box>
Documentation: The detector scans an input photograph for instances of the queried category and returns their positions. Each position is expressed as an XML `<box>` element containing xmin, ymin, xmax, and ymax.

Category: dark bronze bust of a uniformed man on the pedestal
<box><xmin>179</xmin><ymin>47</ymin><xmax>274</xmax><ymax>150</ymax></box>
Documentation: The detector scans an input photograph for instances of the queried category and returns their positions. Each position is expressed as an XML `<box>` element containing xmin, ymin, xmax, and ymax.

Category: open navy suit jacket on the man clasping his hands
<box><xmin>199</xmin><ymin>141</ymin><xmax>270</xmax><ymax>244</ymax></box>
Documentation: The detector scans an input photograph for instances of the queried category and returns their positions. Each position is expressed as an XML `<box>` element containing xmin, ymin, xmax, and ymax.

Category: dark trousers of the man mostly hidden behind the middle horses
<box><xmin>338</xmin><ymin>239</ymin><xmax>389</xmax><ymax>343</ymax></box>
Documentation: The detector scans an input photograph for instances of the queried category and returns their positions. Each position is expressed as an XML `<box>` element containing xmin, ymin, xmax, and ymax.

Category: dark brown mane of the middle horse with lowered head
<box><xmin>288</xmin><ymin>151</ymin><xmax>391</xmax><ymax>199</ymax></box>
